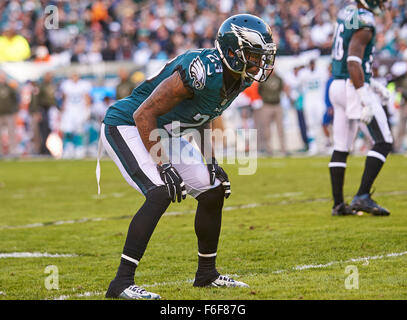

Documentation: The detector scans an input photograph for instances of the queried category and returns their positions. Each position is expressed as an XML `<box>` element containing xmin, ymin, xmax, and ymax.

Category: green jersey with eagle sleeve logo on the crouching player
<box><xmin>104</xmin><ymin>48</ymin><xmax>252</xmax><ymax>136</ymax></box>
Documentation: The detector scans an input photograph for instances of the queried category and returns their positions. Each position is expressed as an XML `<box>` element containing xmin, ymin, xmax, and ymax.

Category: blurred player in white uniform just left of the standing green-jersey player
<box><xmin>298</xmin><ymin>59</ymin><xmax>328</xmax><ymax>156</ymax></box>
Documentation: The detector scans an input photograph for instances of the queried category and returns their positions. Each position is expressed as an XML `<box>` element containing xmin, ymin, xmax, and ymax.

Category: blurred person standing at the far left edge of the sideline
<box><xmin>0</xmin><ymin>72</ymin><xmax>18</xmax><ymax>156</ymax></box>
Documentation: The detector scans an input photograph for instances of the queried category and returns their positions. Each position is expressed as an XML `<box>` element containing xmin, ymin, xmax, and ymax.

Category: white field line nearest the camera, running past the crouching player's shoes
<box><xmin>53</xmin><ymin>251</ymin><xmax>407</xmax><ymax>300</ymax></box>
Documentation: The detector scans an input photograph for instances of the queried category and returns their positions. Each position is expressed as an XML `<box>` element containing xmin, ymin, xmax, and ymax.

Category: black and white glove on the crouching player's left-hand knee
<box><xmin>157</xmin><ymin>163</ymin><xmax>187</xmax><ymax>202</ymax></box>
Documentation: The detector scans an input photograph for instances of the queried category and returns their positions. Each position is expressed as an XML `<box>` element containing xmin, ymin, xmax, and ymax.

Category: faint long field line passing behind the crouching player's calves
<box><xmin>0</xmin><ymin>190</ymin><xmax>407</xmax><ymax>230</ymax></box>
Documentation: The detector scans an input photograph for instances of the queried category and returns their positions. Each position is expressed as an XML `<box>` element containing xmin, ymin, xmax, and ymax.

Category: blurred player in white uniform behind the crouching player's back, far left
<box><xmin>61</xmin><ymin>72</ymin><xmax>92</xmax><ymax>159</ymax></box>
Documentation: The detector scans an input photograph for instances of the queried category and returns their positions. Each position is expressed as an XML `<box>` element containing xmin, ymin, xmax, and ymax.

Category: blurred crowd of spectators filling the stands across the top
<box><xmin>0</xmin><ymin>0</ymin><xmax>407</xmax><ymax>64</ymax></box>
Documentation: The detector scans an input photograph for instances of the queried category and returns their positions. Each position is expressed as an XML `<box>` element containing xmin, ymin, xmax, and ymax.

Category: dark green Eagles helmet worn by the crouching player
<box><xmin>215</xmin><ymin>14</ymin><xmax>277</xmax><ymax>82</ymax></box>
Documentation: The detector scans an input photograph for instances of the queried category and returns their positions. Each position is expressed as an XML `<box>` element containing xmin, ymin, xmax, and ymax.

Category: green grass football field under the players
<box><xmin>0</xmin><ymin>155</ymin><xmax>407</xmax><ymax>300</ymax></box>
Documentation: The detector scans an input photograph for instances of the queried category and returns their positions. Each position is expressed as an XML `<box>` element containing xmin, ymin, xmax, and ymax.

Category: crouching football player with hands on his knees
<box><xmin>101</xmin><ymin>14</ymin><xmax>276</xmax><ymax>299</ymax></box>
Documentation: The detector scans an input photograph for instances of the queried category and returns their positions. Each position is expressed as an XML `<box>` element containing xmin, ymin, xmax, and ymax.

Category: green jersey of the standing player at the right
<box><xmin>332</xmin><ymin>5</ymin><xmax>376</xmax><ymax>82</ymax></box>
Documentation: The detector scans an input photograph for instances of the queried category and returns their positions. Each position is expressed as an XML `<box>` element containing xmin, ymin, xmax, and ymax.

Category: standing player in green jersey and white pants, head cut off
<box><xmin>329</xmin><ymin>0</ymin><xmax>393</xmax><ymax>215</ymax></box>
